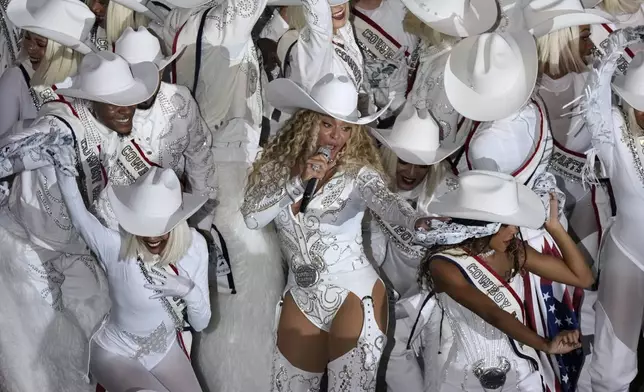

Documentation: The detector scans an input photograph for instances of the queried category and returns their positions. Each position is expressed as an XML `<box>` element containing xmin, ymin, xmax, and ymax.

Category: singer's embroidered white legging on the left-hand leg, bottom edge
<box><xmin>271</xmin><ymin>346</ymin><xmax>323</xmax><ymax>392</ymax></box>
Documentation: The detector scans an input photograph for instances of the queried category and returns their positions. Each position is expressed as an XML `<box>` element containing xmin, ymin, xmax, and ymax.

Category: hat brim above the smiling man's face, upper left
<box><xmin>56</xmin><ymin>62</ymin><xmax>159</xmax><ymax>106</ymax></box>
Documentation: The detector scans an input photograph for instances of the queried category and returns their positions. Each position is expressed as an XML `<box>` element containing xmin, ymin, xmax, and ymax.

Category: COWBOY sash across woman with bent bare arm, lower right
<box><xmin>438</xmin><ymin>253</ymin><xmax>540</xmax><ymax>371</ymax></box>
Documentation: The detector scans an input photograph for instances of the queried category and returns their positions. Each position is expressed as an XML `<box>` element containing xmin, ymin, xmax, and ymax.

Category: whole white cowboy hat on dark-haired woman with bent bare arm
<box><xmin>427</xmin><ymin>170</ymin><xmax>546</xmax><ymax>229</ymax></box>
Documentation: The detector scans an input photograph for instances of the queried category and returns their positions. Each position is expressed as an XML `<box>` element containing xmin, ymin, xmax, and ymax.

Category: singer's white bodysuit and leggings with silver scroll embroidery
<box><xmin>242</xmin><ymin>165</ymin><xmax>419</xmax><ymax>391</ymax></box>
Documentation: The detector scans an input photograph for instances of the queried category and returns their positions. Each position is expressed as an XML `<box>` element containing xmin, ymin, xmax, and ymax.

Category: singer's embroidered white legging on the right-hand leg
<box><xmin>327</xmin><ymin>297</ymin><xmax>387</xmax><ymax>392</ymax></box>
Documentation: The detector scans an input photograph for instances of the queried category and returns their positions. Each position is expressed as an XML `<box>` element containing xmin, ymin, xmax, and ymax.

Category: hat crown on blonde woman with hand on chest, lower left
<box><xmin>121</xmin><ymin>166</ymin><xmax>183</xmax><ymax>218</ymax></box>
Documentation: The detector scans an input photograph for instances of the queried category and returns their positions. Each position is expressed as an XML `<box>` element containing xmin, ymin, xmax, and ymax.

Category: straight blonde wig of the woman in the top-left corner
<box><xmin>26</xmin><ymin>39</ymin><xmax>83</xmax><ymax>86</ymax></box>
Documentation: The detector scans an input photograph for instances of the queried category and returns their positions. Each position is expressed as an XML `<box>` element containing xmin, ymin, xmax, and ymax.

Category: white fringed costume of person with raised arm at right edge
<box><xmin>585</xmin><ymin>30</ymin><xmax>644</xmax><ymax>392</ymax></box>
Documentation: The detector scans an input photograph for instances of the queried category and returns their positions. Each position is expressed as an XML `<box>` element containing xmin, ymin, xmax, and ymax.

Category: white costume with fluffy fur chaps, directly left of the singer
<box><xmin>164</xmin><ymin>1</ymin><xmax>284</xmax><ymax>392</ymax></box>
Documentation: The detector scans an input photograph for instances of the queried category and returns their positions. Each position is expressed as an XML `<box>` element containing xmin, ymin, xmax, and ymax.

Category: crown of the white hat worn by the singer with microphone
<box><xmin>311</xmin><ymin>74</ymin><xmax>358</xmax><ymax>117</ymax></box>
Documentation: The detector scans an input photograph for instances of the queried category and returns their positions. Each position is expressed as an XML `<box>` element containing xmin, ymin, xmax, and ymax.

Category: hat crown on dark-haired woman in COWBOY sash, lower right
<box><xmin>456</xmin><ymin>170</ymin><xmax>519</xmax><ymax>216</ymax></box>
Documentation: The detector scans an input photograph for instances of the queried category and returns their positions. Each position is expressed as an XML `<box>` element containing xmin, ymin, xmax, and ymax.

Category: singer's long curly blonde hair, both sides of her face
<box><xmin>246</xmin><ymin>110</ymin><xmax>384</xmax><ymax>191</ymax></box>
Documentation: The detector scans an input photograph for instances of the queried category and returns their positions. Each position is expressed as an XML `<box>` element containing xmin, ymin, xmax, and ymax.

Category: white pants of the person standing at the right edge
<box><xmin>590</xmin><ymin>234</ymin><xmax>644</xmax><ymax>392</ymax></box>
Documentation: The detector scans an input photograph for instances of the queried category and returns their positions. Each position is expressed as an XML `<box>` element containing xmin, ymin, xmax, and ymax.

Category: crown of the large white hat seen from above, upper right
<box><xmin>459</xmin><ymin>33</ymin><xmax>523</xmax><ymax>96</ymax></box>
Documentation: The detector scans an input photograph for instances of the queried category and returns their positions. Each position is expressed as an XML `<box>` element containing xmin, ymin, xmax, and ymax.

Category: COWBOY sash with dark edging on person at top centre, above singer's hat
<box><xmin>351</xmin><ymin>8</ymin><xmax>409</xmax><ymax>60</ymax></box>
